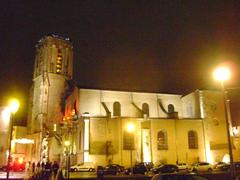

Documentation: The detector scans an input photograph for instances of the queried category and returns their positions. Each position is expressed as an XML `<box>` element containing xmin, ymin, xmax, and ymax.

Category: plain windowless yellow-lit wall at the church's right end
<box><xmin>202</xmin><ymin>91</ymin><xmax>228</xmax><ymax>162</ymax></box>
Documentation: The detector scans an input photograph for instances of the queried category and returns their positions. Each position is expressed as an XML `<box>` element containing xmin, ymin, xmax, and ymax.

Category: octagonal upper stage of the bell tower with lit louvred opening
<box><xmin>33</xmin><ymin>35</ymin><xmax>73</xmax><ymax>79</ymax></box>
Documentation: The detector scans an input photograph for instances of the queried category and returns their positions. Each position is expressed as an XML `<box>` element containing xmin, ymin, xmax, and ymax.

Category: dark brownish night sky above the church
<box><xmin>0</xmin><ymin>0</ymin><xmax>240</xmax><ymax>125</ymax></box>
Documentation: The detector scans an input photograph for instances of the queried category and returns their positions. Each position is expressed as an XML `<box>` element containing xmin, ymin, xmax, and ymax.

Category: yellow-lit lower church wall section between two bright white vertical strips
<box><xmin>90</xmin><ymin>118</ymin><xmax>142</xmax><ymax>166</ymax></box>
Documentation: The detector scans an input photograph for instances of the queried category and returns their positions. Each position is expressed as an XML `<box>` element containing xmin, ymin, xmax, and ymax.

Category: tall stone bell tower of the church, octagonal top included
<box><xmin>28</xmin><ymin>35</ymin><xmax>73</xmax><ymax>133</ymax></box>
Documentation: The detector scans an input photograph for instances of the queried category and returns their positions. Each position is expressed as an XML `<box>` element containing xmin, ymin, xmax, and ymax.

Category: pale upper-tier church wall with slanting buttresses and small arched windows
<box><xmin>79</xmin><ymin>89</ymin><xmax>182</xmax><ymax>118</ymax></box>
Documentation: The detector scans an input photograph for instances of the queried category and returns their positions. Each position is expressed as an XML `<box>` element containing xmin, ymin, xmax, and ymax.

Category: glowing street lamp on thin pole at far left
<box><xmin>7</xmin><ymin>99</ymin><xmax>20</xmax><ymax>179</ymax></box>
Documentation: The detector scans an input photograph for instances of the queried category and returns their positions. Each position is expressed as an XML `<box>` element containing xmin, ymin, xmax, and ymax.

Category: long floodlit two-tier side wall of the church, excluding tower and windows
<box><xmin>75</xmin><ymin>89</ymin><xmax>229</xmax><ymax>166</ymax></box>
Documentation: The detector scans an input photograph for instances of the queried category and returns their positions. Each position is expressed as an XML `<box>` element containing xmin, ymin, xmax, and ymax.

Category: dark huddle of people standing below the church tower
<box><xmin>29</xmin><ymin>161</ymin><xmax>59</xmax><ymax>179</ymax></box>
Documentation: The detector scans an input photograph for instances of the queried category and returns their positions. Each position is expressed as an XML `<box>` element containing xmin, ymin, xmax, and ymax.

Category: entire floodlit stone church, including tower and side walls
<box><xmin>28</xmin><ymin>35</ymin><xmax>240</xmax><ymax>166</ymax></box>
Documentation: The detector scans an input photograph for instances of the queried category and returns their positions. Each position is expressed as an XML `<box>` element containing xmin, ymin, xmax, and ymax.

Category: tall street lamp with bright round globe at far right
<box><xmin>213</xmin><ymin>67</ymin><xmax>235</xmax><ymax>179</ymax></box>
